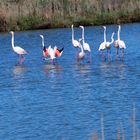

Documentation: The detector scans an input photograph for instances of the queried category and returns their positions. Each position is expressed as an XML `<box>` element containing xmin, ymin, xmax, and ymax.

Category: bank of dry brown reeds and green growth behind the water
<box><xmin>0</xmin><ymin>0</ymin><xmax>140</xmax><ymax>31</ymax></box>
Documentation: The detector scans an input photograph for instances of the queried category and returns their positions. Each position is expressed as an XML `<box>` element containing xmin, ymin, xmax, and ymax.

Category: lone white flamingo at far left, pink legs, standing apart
<box><xmin>10</xmin><ymin>31</ymin><xmax>27</xmax><ymax>64</ymax></box>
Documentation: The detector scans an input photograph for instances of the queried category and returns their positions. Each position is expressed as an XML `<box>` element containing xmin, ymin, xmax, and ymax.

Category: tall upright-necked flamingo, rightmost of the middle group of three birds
<box><xmin>79</xmin><ymin>26</ymin><xmax>91</xmax><ymax>63</ymax></box>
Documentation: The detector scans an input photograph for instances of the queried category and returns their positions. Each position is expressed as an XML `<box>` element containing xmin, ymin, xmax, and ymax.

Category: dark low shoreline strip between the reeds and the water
<box><xmin>0</xmin><ymin>18</ymin><xmax>140</xmax><ymax>32</ymax></box>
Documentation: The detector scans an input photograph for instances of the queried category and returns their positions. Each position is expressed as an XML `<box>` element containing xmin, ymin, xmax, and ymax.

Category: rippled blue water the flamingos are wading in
<box><xmin>0</xmin><ymin>23</ymin><xmax>140</xmax><ymax>140</ymax></box>
